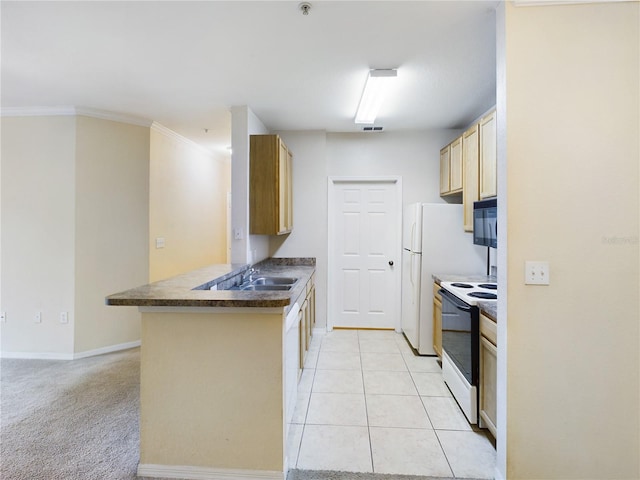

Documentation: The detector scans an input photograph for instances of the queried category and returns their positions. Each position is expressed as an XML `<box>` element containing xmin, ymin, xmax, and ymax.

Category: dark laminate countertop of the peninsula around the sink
<box><xmin>105</xmin><ymin>258</ymin><xmax>315</xmax><ymax>308</ymax></box>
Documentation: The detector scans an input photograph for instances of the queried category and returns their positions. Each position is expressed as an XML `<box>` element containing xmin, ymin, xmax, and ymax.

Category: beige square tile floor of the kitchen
<box><xmin>288</xmin><ymin>330</ymin><xmax>496</xmax><ymax>478</ymax></box>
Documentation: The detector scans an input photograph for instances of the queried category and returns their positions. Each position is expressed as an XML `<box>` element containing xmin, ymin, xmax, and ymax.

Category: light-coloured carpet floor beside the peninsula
<box><xmin>0</xmin><ymin>349</ymin><xmax>480</xmax><ymax>480</ymax></box>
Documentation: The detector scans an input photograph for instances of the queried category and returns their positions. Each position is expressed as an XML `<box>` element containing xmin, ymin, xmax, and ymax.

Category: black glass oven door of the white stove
<box><xmin>442</xmin><ymin>291</ymin><xmax>476</xmax><ymax>385</ymax></box>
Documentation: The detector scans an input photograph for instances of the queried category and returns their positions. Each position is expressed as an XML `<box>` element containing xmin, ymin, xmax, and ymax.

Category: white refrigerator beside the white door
<box><xmin>402</xmin><ymin>203</ymin><xmax>487</xmax><ymax>355</ymax></box>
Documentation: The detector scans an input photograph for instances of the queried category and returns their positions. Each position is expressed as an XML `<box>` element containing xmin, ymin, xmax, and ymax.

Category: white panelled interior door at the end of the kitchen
<box><xmin>327</xmin><ymin>178</ymin><xmax>402</xmax><ymax>331</ymax></box>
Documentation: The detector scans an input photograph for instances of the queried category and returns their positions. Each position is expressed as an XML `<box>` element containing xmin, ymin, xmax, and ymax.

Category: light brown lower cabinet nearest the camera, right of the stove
<box><xmin>479</xmin><ymin>314</ymin><xmax>498</xmax><ymax>437</ymax></box>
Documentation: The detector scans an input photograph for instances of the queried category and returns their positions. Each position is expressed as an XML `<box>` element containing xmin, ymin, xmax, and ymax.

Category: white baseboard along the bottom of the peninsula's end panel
<box><xmin>138</xmin><ymin>463</ymin><xmax>286</xmax><ymax>480</ymax></box>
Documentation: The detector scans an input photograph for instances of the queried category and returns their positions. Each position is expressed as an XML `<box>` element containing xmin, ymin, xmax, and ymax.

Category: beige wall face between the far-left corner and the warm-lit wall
<box><xmin>74</xmin><ymin>116</ymin><xmax>149</xmax><ymax>353</ymax></box>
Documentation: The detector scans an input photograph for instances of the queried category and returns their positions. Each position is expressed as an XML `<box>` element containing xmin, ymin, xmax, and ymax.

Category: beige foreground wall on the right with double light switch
<box><xmin>499</xmin><ymin>2</ymin><xmax>640</xmax><ymax>479</ymax></box>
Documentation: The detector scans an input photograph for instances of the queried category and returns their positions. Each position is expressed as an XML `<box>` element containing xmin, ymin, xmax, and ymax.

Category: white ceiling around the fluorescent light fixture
<box><xmin>0</xmin><ymin>0</ymin><xmax>498</xmax><ymax>156</ymax></box>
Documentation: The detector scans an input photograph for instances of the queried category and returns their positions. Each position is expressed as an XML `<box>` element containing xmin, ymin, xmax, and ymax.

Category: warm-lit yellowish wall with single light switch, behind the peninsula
<box><xmin>148</xmin><ymin>127</ymin><xmax>231</xmax><ymax>281</ymax></box>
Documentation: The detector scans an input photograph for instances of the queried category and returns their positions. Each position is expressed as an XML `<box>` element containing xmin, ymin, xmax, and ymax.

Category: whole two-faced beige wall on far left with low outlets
<box><xmin>1</xmin><ymin>113</ymin><xmax>149</xmax><ymax>358</ymax></box>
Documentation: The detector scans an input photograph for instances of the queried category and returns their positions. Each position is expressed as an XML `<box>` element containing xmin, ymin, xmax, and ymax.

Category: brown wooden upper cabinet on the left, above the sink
<box><xmin>249</xmin><ymin>135</ymin><xmax>293</xmax><ymax>235</ymax></box>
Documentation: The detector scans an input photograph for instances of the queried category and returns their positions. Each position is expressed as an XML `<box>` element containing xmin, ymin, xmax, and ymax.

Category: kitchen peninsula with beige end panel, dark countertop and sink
<box><xmin>106</xmin><ymin>258</ymin><xmax>315</xmax><ymax>480</ymax></box>
